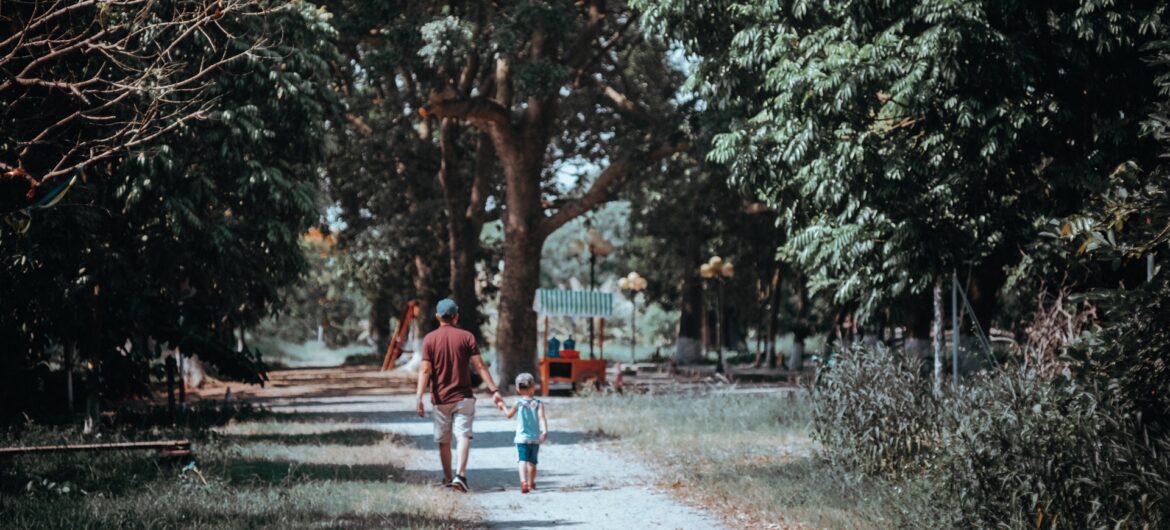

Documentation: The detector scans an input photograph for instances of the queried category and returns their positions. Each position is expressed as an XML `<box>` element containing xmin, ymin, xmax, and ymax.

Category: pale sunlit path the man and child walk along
<box><xmin>221</xmin><ymin>369</ymin><xmax>723</xmax><ymax>530</ymax></box>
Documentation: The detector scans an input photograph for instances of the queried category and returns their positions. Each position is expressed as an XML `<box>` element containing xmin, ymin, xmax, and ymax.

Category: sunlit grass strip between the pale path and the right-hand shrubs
<box><xmin>564</xmin><ymin>391</ymin><xmax>914</xmax><ymax>529</ymax></box>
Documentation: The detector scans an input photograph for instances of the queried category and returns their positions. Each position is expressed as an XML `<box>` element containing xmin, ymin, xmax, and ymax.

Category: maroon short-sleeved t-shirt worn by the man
<box><xmin>422</xmin><ymin>325</ymin><xmax>480</xmax><ymax>405</ymax></box>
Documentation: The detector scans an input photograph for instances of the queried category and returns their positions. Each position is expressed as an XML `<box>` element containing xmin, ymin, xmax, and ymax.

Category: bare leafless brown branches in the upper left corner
<box><xmin>0</xmin><ymin>0</ymin><xmax>266</xmax><ymax>213</ymax></box>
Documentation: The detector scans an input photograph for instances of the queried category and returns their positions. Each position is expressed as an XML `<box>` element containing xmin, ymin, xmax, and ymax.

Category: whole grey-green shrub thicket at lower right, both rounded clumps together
<box><xmin>814</xmin><ymin>349</ymin><xmax>1170</xmax><ymax>528</ymax></box>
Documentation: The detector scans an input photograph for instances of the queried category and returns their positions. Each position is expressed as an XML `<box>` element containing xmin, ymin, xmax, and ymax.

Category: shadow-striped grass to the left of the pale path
<box><xmin>0</xmin><ymin>414</ymin><xmax>482</xmax><ymax>530</ymax></box>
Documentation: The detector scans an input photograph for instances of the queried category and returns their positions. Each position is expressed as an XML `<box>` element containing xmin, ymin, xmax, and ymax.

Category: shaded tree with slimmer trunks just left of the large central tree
<box><xmin>331</xmin><ymin>0</ymin><xmax>498</xmax><ymax>343</ymax></box>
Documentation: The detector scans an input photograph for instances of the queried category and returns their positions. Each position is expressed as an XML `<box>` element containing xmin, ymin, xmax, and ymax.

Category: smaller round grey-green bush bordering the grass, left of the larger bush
<box><xmin>813</xmin><ymin>346</ymin><xmax>941</xmax><ymax>477</ymax></box>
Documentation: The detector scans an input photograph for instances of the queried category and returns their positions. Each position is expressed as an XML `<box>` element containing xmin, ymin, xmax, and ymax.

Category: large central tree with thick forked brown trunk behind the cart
<box><xmin>420</xmin><ymin>1</ymin><xmax>682</xmax><ymax>380</ymax></box>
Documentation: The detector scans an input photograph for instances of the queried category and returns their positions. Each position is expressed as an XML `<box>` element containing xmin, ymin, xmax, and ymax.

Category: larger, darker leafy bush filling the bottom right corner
<box><xmin>934</xmin><ymin>371</ymin><xmax>1170</xmax><ymax>528</ymax></box>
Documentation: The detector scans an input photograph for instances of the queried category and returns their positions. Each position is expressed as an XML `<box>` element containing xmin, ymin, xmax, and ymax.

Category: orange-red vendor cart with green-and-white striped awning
<box><xmin>532</xmin><ymin>289</ymin><xmax>613</xmax><ymax>395</ymax></box>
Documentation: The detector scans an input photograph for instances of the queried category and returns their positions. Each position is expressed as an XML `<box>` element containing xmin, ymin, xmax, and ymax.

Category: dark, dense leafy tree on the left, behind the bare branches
<box><xmin>0</xmin><ymin>2</ymin><xmax>337</xmax><ymax>412</ymax></box>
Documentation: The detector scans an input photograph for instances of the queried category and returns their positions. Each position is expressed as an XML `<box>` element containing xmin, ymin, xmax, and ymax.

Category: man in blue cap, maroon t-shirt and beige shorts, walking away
<box><xmin>415</xmin><ymin>298</ymin><xmax>504</xmax><ymax>491</ymax></box>
